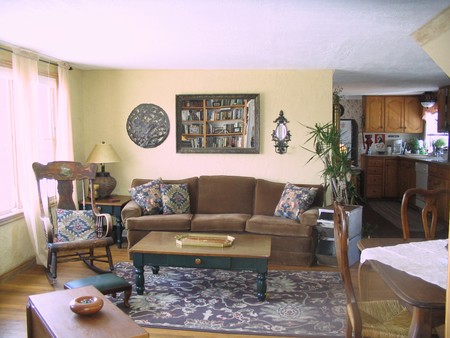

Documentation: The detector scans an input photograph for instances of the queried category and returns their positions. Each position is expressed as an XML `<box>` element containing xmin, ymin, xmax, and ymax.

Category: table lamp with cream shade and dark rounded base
<box><xmin>86</xmin><ymin>142</ymin><xmax>120</xmax><ymax>198</ymax></box>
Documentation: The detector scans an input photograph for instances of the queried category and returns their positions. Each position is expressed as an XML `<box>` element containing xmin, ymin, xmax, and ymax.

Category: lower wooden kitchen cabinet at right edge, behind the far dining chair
<box><xmin>428</xmin><ymin>163</ymin><xmax>450</xmax><ymax>222</ymax></box>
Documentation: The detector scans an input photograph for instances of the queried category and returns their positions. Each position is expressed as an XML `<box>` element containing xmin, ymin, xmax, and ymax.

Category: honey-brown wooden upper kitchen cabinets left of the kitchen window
<box><xmin>363</xmin><ymin>96</ymin><xmax>423</xmax><ymax>133</ymax></box>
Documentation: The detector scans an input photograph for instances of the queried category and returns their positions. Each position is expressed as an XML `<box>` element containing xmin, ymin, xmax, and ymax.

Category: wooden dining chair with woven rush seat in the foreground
<box><xmin>334</xmin><ymin>202</ymin><xmax>412</xmax><ymax>338</ymax></box>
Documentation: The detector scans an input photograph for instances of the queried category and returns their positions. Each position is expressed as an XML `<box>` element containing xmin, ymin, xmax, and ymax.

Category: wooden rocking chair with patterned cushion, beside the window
<box><xmin>33</xmin><ymin>161</ymin><xmax>114</xmax><ymax>284</ymax></box>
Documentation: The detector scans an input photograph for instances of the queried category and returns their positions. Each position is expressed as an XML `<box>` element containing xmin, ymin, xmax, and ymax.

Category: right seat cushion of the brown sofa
<box><xmin>245</xmin><ymin>215</ymin><xmax>314</xmax><ymax>237</ymax></box>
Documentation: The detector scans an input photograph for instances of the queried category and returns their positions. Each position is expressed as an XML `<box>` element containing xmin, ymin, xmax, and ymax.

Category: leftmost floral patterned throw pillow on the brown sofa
<box><xmin>129</xmin><ymin>178</ymin><xmax>162</xmax><ymax>215</ymax></box>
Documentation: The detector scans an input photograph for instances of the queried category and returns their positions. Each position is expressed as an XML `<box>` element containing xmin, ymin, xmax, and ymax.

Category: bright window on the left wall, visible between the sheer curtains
<box><xmin>0</xmin><ymin>67</ymin><xmax>57</xmax><ymax>217</ymax></box>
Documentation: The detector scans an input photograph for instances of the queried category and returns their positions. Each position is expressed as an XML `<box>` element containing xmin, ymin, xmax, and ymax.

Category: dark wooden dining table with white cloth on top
<box><xmin>360</xmin><ymin>239</ymin><xmax>448</xmax><ymax>337</ymax></box>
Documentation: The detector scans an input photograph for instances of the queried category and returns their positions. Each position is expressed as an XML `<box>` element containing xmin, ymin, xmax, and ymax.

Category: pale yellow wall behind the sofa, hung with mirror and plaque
<box><xmin>73</xmin><ymin>70</ymin><xmax>333</xmax><ymax>194</ymax></box>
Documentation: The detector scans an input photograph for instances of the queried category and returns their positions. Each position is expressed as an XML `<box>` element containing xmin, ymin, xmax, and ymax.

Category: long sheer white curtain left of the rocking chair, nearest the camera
<box><xmin>12</xmin><ymin>51</ymin><xmax>46</xmax><ymax>265</ymax></box>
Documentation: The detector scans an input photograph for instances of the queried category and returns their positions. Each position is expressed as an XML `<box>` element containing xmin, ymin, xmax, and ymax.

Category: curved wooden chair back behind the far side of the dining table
<box><xmin>401</xmin><ymin>188</ymin><xmax>450</xmax><ymax>240</ymax></box>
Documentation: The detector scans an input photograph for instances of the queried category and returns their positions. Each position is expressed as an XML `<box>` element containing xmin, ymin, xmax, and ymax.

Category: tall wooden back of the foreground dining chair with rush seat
<box><xmin>334</xmin><ymin>202</ymin><xmax>362</xmax><ymax>337</ymax></box>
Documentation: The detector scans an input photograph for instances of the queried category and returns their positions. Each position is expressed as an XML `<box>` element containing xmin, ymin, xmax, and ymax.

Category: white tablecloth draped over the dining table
<box><xmin>360</xmin><ymin>239</ymin><xmax>448</xmax><ymax>289</ymax></box>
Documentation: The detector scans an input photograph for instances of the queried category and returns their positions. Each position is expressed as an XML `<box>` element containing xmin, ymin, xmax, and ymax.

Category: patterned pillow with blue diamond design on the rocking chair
<box><xmin>55</xmin><ymin>209</ymin><xmax>97</xmax><ymax>242</ymax></box>
